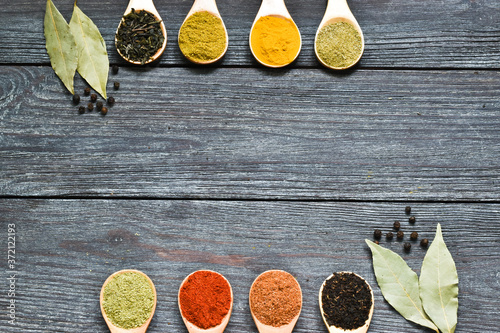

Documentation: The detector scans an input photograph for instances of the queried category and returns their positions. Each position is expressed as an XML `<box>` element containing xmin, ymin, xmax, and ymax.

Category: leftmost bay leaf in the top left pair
<box><xmin>44</xmin><ymin>0</ymin><xmax>78</xmax><ymax>94</ymax></box>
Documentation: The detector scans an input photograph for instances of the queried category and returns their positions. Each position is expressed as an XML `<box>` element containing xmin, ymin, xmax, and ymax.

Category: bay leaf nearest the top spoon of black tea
<box><xmin>69</xmin><ymin>2</ymin><xmax>109</xmax><ymax>98</ymax></box>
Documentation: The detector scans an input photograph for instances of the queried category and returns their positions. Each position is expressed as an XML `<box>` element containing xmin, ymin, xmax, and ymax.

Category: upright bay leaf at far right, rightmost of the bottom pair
<box><xmin>420</xmin><ymin>224</ymin><xmax>458</xmax><ymax>333</ymax></box>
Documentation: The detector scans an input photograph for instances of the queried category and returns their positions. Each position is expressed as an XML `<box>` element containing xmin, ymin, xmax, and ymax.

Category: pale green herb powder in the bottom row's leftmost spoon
<box><xmin>103</xmin><ymin>272</ymin><xmax>155</xmax><ymax>329</ymax></box>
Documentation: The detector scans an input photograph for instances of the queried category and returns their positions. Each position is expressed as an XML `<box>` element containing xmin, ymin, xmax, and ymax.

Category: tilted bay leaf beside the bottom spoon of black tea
<box><xmin>365</xmin><ymin>239</ymin><xmax>438</xmax><ymax>332</ymax></box>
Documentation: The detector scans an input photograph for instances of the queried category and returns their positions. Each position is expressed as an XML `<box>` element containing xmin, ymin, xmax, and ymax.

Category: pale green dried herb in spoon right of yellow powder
<box><xmin>316</xmin><ymin>22</ymin><xmax>362</xmax><ymax>68</ymax></box>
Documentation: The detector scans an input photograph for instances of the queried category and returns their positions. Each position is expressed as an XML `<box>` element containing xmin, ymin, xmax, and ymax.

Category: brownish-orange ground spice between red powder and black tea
<box><xmin>250</xmin><ymin>271</ymin><xmax>302</xmax><ymax>327</ymax></box>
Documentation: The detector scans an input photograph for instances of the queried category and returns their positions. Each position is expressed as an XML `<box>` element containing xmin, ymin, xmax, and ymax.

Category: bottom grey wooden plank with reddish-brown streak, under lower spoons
<box><xmin>0</xmin><ymin>199</ymin><xmax>500</xmax><ymax>333</ymax></box>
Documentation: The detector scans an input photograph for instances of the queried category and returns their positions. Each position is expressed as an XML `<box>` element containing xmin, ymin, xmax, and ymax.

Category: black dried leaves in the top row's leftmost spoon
<box><xmin>116</xmin><ymin>8</ymin><xmax>165</xmax><ymax>64</ymax></box>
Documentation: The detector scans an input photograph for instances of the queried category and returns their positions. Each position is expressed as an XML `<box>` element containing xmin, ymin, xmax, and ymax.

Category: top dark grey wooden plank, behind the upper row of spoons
<box><xmin>0</xmin><ymin>0</ymin><xmax>500</xmax><ymax>68</ymax></box>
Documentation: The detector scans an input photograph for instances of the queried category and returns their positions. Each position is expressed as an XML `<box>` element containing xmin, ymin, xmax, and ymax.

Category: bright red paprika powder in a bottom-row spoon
<box><xmin>179</xmin><ymin>271</ymin><xmax>232</xmax><ymax>329</ymax></box>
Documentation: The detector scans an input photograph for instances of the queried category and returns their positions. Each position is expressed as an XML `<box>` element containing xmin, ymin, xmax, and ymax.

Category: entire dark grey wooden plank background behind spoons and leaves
<box><xmin>0</xmin><ymin>0</ymin><xmax>500</xmax><ymax>333</ymax></box>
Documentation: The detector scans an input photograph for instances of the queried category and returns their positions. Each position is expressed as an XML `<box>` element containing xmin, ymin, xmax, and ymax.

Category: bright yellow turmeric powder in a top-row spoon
<box><xmin>250</xmin><ymin>16</ymin><xmax>301</xmax><ymax>67</ymax></box>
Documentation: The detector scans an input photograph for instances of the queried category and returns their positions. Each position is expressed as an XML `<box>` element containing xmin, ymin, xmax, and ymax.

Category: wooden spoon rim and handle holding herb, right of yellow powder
<box><xmin>314</xmin><ymin>0</ymin><xmax>365</xmax><ymax>69</ymax></box>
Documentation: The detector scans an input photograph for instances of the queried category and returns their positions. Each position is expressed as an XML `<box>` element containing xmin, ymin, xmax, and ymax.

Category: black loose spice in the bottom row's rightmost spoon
<box><xmin>321</xmin><ymin>273</ymin><xmax>372</xmax><ymax>330</ymax></box>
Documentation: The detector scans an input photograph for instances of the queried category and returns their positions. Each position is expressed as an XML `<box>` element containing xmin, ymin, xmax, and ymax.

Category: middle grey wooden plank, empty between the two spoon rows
<box><xmin>0</xmin><ymin>66</ymin><xmax>500</xmax><ymax>201</ymax></box>
